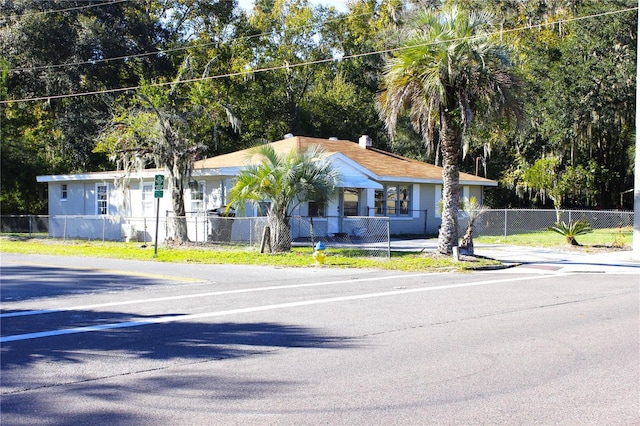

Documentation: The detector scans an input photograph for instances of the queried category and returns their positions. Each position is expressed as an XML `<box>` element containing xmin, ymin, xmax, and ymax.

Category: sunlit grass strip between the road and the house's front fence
<box><xmin>0</xmin><ymin>235</ymin><xmax>498</xmax><ymax>271</ymax></box>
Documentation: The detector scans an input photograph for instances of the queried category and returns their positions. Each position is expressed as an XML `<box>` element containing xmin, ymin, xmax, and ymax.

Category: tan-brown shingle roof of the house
<box><xmin>194</xmin><ymin>136</ymin><xmax>496</xmax><ymax>186</ymax></box>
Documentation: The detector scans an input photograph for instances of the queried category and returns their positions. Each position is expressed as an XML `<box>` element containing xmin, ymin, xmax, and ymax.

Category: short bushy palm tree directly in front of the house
<box><xmin>229</xmin><ymin>145</ymin><xmax>339</xmax><ymax>253</ymax></box>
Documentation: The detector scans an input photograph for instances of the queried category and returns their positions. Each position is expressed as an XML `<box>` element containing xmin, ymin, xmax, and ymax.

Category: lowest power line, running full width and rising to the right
<box><xmin>0</xmin><ymin>7</ymin><xmax>638</xmax><ymax>105</ymax></box>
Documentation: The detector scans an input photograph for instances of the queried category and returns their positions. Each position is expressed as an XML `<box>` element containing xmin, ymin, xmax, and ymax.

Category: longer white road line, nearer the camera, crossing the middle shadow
<box><xmin>0</xmin><ymin>274</ymin><xmax>573</xmax><ymax>343</ymax></box>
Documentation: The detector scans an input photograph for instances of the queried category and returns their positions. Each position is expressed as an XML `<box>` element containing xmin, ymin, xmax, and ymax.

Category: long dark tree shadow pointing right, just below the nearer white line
<box><xmin>1</xmin><ymin>318</ymin><xmax>351</xmax><ymax>372</ymax></box>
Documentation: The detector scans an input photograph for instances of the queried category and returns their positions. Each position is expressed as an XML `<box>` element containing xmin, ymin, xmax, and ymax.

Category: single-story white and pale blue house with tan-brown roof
<box><xmin>37</xmin><ymin>136</ymin><xmax>497</xmax><ymax>241</ymax></box>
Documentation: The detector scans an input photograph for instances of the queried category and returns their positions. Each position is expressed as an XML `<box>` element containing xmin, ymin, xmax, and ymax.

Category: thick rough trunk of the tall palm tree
<box><xmin>438</xmin><ymin>108</ymin><xmax>462</xmax><ymax>254</ymax></box>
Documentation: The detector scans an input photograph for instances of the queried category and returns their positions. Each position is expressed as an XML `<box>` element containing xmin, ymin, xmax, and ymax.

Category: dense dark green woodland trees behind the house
<box><xmin>0</xmin><ymin>0</ymin><xmax>637</xmax><ymax>218</ymax></box>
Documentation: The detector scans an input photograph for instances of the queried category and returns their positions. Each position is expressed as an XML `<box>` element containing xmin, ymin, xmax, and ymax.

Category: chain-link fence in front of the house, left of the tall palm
<box><xmin>0</xmin><ymin>213</ymin><xmax>391</xmax><ymax>258</ymax></box>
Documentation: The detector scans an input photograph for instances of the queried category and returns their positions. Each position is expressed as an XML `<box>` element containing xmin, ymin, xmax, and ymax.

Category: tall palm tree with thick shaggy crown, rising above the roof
<box><xmin>379</xmin><ymin>7</ymin><xmax>519</xmax><ymax>254</ymax></box>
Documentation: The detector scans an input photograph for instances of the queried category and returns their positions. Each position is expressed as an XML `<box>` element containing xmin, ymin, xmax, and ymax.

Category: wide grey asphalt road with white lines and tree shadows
<box><xmin>0</xmin><ymin>253</ymin><xmax>640</xmax><ymax>425</ymax></box>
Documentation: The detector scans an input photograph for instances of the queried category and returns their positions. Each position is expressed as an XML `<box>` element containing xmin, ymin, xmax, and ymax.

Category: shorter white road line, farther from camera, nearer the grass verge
<box><xmin>0</xmin><ymin>272</ymin><xmax>448</xmax><ymax>318</ymax></box>
